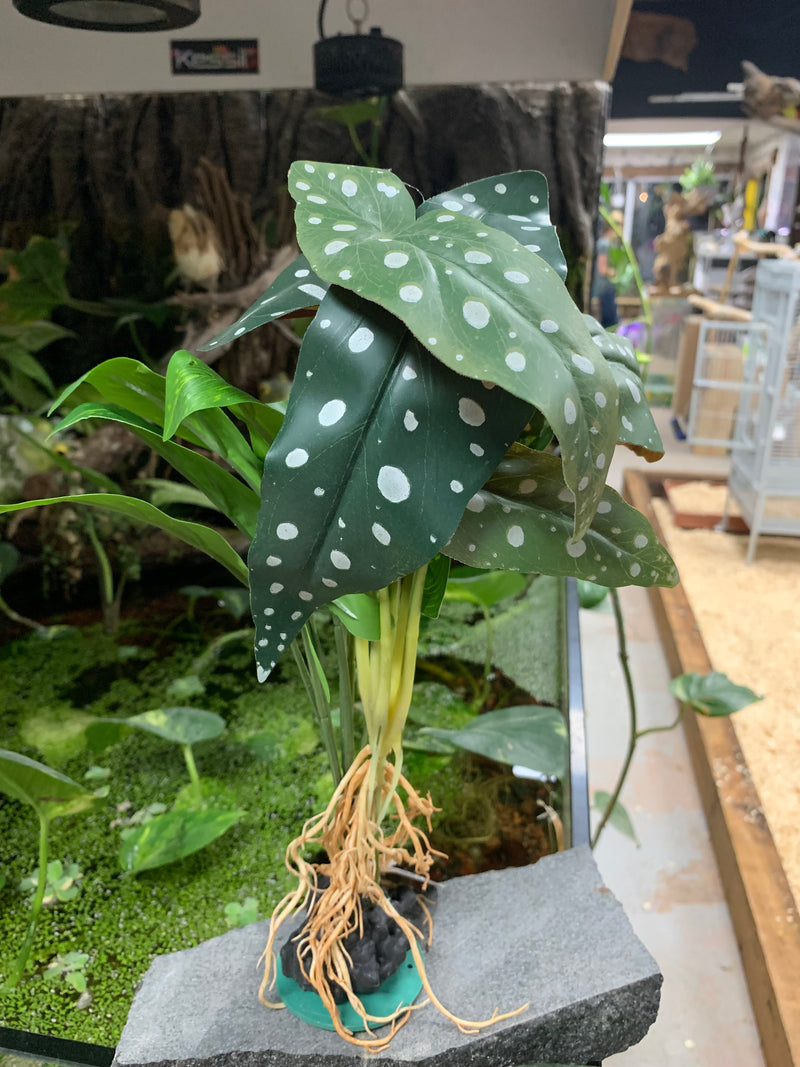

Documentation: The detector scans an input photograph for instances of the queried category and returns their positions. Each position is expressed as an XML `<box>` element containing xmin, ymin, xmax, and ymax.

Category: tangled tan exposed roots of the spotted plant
<box><xmin>258</xmin><ymin>746</ymin><xmax>527</xmax><ymax>1052</ymax></box>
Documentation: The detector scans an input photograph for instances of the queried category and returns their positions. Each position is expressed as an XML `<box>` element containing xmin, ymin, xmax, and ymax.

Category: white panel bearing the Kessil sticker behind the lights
<box><xmin>0</xmin><ymin>0</ymin><xmax>617</xmax><ymax>96</ymax></box>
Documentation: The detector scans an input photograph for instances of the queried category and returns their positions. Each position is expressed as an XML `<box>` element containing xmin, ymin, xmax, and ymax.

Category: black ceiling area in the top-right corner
<box><xmin>611</xmin><ymin>0</ymin><xmax>800</xmax><ymax>118</ymax></box>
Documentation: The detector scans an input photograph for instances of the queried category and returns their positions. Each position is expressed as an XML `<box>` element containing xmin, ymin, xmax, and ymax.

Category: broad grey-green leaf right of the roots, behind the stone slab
<box><xmin>419</xmin><ymin>704</ymin><xmax>567</xmax><ymax>778</ymax></box>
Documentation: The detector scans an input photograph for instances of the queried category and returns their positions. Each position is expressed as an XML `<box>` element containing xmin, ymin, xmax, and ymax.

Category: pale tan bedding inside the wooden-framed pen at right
<box><xmin>653</xmin><ymin>487</ymin><xmax>800</xmax><ymax>901</ymax></box>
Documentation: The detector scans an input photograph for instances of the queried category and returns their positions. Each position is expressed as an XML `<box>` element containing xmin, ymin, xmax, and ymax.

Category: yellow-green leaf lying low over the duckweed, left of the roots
<box><xmin>119</xmin><ymin>809</ymin><xmax>246</xmax><ymax>874</ymax></box>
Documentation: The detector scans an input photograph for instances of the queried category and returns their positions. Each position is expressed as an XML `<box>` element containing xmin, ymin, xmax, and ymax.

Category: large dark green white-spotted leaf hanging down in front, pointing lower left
<box><xmin>247</xmin><ymin>286</ymin><xmax>539</xmax><ymax>680</ymax></box>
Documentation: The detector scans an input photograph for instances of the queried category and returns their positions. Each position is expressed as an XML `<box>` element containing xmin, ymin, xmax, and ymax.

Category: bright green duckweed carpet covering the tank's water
<box><xmin>0</xmin><ymin>580</ymin><xmax>558</xmax><ymax>1045</ymax></box>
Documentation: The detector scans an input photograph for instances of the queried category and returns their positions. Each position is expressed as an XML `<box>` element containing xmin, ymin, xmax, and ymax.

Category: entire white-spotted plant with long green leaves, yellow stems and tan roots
<box><xmin>1</xmin><ymin>161</ymin><xmax>677</xmax><ymax>1051</ymax></box>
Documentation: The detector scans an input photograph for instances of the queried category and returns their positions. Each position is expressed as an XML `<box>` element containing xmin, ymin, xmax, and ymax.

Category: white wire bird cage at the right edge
<box><xmin>725</xmin><ymin>259</ymin><xmax>800</xmax><ymax>563</ymax></box>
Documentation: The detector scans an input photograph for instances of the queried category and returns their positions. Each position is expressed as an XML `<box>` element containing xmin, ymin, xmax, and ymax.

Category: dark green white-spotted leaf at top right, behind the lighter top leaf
<box><xmin>417</xmin><ymin>171</ymin><xmax>566</xmax><ymax>278</ymax></box>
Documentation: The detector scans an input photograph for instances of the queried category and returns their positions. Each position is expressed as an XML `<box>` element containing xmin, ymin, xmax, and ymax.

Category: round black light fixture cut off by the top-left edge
<box><xmin>14</xmin><ymin>0</ymin><xmax>199</xmax><ymax>33</ymax></box>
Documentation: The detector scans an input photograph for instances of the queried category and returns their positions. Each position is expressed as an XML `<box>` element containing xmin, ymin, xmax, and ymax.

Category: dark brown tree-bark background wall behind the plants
<box><xmin>0</xmin><ymin>82</ymin><xmax>609</xmax><ymax>380</ymax></box>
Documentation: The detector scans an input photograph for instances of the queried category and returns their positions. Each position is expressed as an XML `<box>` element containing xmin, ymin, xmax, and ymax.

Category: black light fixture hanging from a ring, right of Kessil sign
<box><xmin>314</xmin><ymin>0</ymin><xmax>403</xmax><ymax>96</ymax></box>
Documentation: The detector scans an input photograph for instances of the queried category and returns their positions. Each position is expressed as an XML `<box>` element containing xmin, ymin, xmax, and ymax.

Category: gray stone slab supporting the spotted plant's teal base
<box><xmin>115</xmin><ymin>847</ymin><xmax>661</xmax><ymax>1067</ymax></box>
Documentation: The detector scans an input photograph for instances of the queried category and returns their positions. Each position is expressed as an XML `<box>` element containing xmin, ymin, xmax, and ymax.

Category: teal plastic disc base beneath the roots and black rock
<box><xmin>275</xmin><ymin>949</ymin><xmax>422</xmax><ymax>1033</ymax></box>
